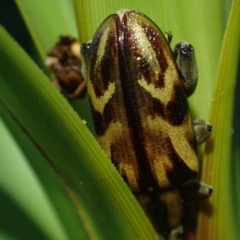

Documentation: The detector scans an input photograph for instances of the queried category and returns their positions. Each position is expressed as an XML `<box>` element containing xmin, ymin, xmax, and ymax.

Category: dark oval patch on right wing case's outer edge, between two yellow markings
<box><xmin>166</xmin><ymin>84</ymin><xmax>188</xmax><ymax>126</ymax></box>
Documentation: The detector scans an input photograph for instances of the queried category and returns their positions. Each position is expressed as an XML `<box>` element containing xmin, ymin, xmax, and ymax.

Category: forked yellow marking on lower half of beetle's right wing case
<box><xmin>144</xmin><ymin>115</ymin><xmax>199</xmax><ymax>187</ymax></box>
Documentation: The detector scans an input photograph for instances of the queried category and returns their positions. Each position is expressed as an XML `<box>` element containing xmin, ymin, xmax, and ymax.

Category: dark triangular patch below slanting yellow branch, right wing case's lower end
<box><xmin>166</xmin><ymin>138</ymin><xmax>197</xmax><ymax>187</ymax></box>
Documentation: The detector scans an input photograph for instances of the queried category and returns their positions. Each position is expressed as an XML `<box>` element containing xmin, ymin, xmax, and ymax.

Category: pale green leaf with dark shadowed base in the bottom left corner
<box><xmin>0</xmin><ymin>114</ymin><xmax>68</xmax><ymax>240</ymax></box>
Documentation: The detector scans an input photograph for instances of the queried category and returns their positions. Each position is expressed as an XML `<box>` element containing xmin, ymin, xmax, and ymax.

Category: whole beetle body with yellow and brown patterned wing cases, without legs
<box><xmin>81</xmin><ymin>10</ymin><xmax>212</xmax><ymax>239</ymax></box>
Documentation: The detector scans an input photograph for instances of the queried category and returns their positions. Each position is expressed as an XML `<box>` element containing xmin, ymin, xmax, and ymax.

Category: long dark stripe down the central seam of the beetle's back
<box><xmin>119</xmin><ymin>14</ymin><xmax>159</xmax><ymax>192</ymax></box>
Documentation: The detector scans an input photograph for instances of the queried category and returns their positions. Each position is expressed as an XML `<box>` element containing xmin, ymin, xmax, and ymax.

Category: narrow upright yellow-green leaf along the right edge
<box><xmin>199</xmin><ymin>0</ymin><xmax>240</xmax><ymax>239</ymax></box>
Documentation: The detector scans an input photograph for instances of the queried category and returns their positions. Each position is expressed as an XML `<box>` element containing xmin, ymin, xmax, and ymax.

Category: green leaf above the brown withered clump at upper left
<box><xmin>16</xmin><ymin>0</ymin><xmax>77</xmax><ymax>62</ymax></box>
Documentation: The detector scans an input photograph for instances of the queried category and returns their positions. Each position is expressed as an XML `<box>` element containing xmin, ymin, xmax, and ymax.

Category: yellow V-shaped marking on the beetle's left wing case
<box><xmin>87</xmin><ymin>82</ymin><xmax>115</xmax><ymax>113</ymax></box>
